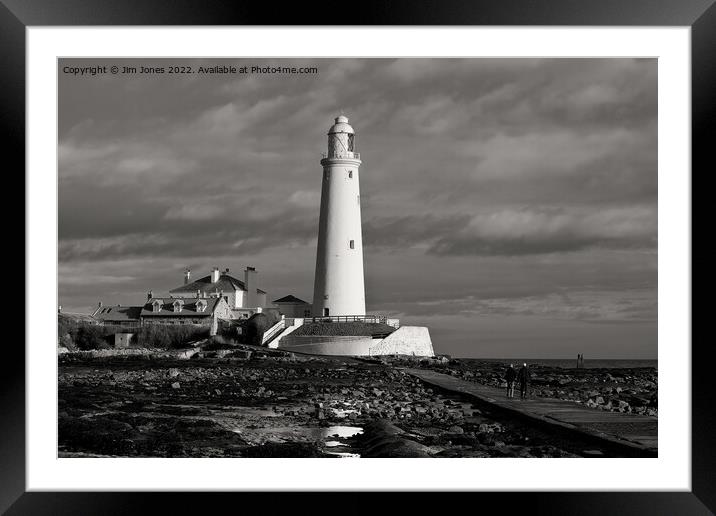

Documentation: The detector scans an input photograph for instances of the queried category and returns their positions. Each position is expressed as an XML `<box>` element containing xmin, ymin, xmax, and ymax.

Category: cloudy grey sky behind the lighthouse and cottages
<box><xmin>58</xmin><ymin>58</ymin><xmax>657</xmax><ymax>360</ymax></box>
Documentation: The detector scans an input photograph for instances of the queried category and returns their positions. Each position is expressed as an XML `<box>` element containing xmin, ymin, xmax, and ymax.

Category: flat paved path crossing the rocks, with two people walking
<box><xmin>405</xmin><ymin>368</ymin><xmax>658</xmax><ymax>455</ymax></box>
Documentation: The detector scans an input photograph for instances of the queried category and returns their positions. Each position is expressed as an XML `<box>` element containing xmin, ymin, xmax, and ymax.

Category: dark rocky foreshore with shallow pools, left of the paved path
<box><xmin>59</xmin><ymin>349</ymin><xmax>636</xmax><ymax>457</ymax></box>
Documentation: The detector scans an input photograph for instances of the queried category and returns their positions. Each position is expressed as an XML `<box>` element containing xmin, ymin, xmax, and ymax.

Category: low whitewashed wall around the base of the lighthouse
<box><xmin>278</xmin><ymin>326</ymin><xmax>435</xmax><ymax>357</ymax></box>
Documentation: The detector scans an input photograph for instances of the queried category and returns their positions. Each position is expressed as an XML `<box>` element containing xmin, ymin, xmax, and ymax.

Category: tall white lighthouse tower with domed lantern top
<box><xmin>313</xmin><ymin>115</ymin><xmax>365</xmax><ymax>316</ymax></box>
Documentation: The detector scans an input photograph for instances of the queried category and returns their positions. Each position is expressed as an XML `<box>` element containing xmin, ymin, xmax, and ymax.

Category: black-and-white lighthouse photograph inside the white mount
<box><xmin>56</xmin><ymin>57</ymin><xmax>658</xmax><ymax>464</ymax></box>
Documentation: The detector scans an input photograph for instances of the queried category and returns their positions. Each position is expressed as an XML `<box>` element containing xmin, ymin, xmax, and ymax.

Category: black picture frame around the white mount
<box><xmin>0</xmin><ymin>0</ymin><xmax>716</xmax><ymax>515</ymax></box>
